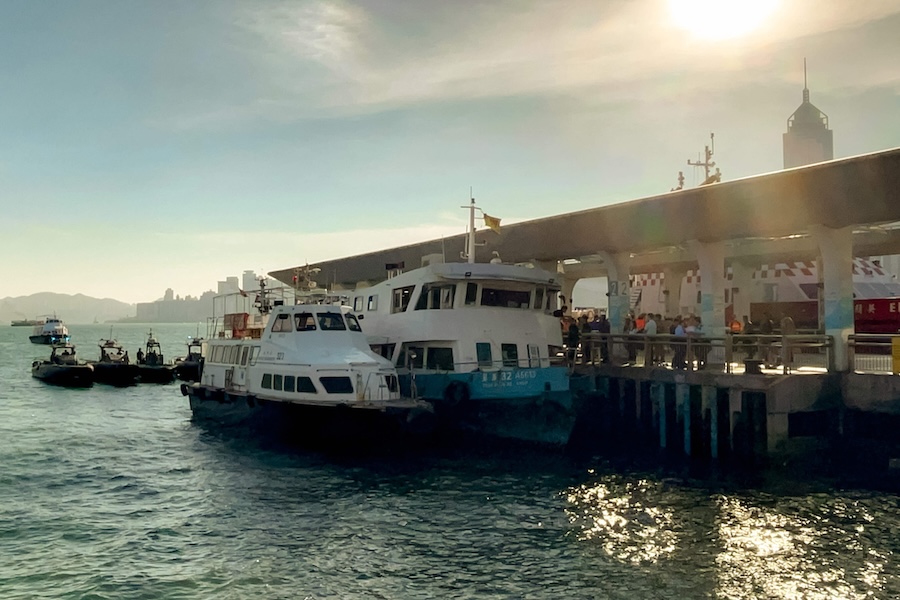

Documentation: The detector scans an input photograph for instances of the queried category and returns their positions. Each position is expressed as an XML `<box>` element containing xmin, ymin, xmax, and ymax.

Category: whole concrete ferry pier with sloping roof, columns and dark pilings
<box><xmin>270</xmin><ymin>148</ymin><xmax>900</xmax><ymax>469</ymax></box>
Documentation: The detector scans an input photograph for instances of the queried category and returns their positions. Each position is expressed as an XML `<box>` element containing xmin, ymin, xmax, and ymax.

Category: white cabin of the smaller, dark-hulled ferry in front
<box><xmin>199</xmin><ymin>305</ymin><xmax>400</xmax><ymax>405</ymax></box>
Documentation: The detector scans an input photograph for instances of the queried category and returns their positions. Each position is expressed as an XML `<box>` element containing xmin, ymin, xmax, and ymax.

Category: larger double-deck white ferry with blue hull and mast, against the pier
<box><xmin>342</xmin><ymin>201</ymin><xmax>576</xmax><ymax>445</ymax></box>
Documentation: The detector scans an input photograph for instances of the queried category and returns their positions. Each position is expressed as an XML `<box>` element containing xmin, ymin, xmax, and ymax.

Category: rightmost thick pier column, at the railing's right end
<box><xmin>812</xmin><ymin>225</ymin><xmax>853</xmax><ymax>371</ymax></box>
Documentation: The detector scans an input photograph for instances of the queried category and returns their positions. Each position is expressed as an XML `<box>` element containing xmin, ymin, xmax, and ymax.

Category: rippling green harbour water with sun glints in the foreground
<box><xmin>0</xmin><ymin>325</ymin><xmax>900</xmax><ymax>600</ymax></box>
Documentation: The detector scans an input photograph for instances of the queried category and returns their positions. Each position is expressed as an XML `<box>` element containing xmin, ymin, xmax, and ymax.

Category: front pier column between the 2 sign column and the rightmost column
<box><xmin>690</xmin><ymin>241</ymin><xmax>726</xmax><ymax>370</ymax></box>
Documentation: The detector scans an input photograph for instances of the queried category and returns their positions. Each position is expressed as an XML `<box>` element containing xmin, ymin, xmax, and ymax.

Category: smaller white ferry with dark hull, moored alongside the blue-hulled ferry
<box><xmin>181</xmin><ymin>281</ymin><xmax>434</xmax><ymax>442</ymax></box>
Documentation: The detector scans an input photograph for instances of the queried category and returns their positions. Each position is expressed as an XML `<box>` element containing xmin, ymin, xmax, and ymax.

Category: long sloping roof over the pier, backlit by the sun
<box><xmin>270</xmin><ymin>148</ymin><xmax>900</xmax><ymax>287</ymax></box>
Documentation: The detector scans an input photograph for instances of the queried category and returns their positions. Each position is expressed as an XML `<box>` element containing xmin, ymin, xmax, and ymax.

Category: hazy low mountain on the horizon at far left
<box><xmin>0</xmin><ymin>292</ymin><xmax>136</xmax><ymax>325</ymax></box>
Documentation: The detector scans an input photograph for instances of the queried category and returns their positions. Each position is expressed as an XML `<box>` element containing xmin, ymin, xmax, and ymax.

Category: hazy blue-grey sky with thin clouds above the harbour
<box><xmin>0</xmin><ymin>0</ymin><xmax>900</xmax><ymax>303</ymax></box>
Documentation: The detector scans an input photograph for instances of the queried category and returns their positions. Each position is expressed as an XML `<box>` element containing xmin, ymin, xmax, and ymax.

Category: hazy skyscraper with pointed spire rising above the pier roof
<box><xmin>783</xmin><ymin>59</ymin><xmax>834</xmax><ymax>169</ymax></box>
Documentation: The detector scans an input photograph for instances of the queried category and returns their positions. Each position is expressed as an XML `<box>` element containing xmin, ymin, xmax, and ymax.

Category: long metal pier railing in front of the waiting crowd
<box><xmin>568</xmin><ymin>333</ymin><xmax>834</xmax><ymax>374</ymax></box>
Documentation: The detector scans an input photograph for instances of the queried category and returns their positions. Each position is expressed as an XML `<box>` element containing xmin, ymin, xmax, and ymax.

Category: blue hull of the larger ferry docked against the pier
<box><xmin>400</xmin><ymin>367</ymin><xmax>577</xmax><ymax>446</ymax></box>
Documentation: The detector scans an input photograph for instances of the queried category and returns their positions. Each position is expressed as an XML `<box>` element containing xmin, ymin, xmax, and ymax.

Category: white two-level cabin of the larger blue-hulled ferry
<box><xmin>353</xmin><ymin>263</ymin><xmax>562</xmax><ymax>373</ymax></box>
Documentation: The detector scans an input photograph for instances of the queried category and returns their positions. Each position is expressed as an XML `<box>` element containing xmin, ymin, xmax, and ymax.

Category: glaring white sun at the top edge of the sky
<box><xmin>669</xmin><ymin>0</ymin><xmax>778</xmax><ymax>40</ymax></box>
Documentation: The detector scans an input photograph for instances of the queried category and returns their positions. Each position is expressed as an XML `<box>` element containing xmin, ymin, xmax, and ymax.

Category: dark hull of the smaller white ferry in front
<box><xmin>181</xmin><ymin>383</ymin><xmax>435</xmax><ymax>448</ymax></box>
